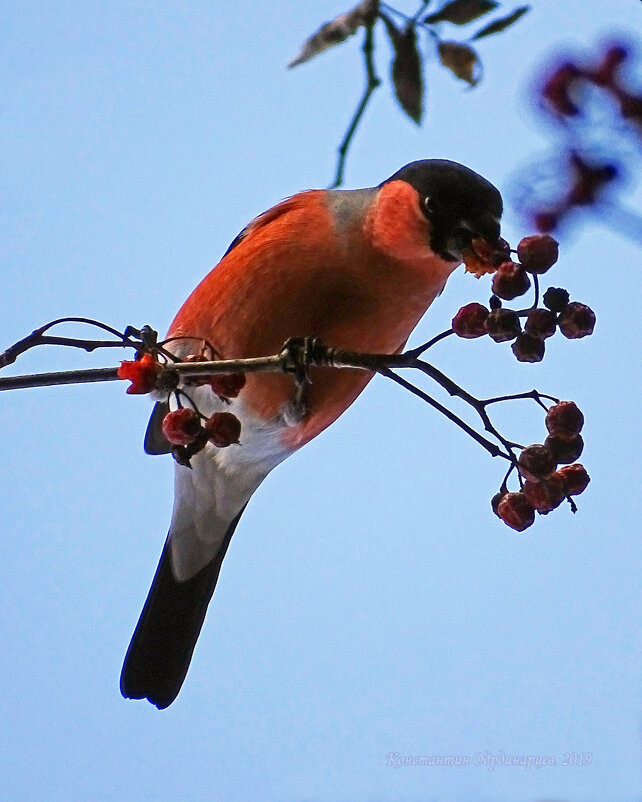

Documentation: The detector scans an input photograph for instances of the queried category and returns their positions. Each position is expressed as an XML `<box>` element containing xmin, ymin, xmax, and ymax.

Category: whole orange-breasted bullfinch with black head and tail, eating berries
<box><xmin>120</xmin><ymin>159</ymin><xmax>503</xmax><ymax>709</ymax></box>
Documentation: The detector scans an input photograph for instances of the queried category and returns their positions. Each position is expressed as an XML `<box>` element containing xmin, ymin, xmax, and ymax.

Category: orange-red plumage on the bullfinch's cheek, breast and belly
<box><xmin>169</xmin><ymin>181</ymin><xmax>457</xmax><ymax>447</ymax></box>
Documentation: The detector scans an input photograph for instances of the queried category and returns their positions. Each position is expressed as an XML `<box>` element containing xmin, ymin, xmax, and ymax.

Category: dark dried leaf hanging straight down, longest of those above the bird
<box><xmin>380</xmin><ymin>14</ymin><xmax>424</xmax><ymax>124</ymax></box>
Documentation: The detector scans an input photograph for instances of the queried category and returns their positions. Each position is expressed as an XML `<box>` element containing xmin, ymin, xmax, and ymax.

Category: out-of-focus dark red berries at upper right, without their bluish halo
<box><xmin>533</xmin><ymin>44</ymin><xmax>642</xmax><ymax>232</ymax></box>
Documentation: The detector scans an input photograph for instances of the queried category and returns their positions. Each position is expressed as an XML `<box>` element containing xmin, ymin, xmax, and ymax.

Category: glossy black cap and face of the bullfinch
<box><xmin>381</xmin><ymin>159</ymin><xmax>503</xmax><ymax>261</ymax></box>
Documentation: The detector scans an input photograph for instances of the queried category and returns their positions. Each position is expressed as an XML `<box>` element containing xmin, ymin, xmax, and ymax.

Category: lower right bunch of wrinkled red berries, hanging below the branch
<box><xmin>491</xmin><ymin>401</ymin><xmax>590</xmax><ymax>532</ymax></box>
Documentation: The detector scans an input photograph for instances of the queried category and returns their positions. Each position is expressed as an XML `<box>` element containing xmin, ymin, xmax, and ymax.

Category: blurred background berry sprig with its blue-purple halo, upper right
<box><xmin>513</xmin><ymin>40</ymin><xmax>642</xmax><ymax>242</ymax></box>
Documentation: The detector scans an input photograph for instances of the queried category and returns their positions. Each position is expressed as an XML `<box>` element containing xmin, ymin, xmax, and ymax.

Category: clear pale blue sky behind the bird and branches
<box><xmin>0</xmin><ymin>0</ymin><xmax>642</xmax><ymax>802</ymax></box>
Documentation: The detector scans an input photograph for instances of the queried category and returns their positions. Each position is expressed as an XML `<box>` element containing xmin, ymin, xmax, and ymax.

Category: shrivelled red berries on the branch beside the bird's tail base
<box><xmin>118</xmin><ymin>353</ymin><xmax>246</xmax><ymax>465</ymax></box>
